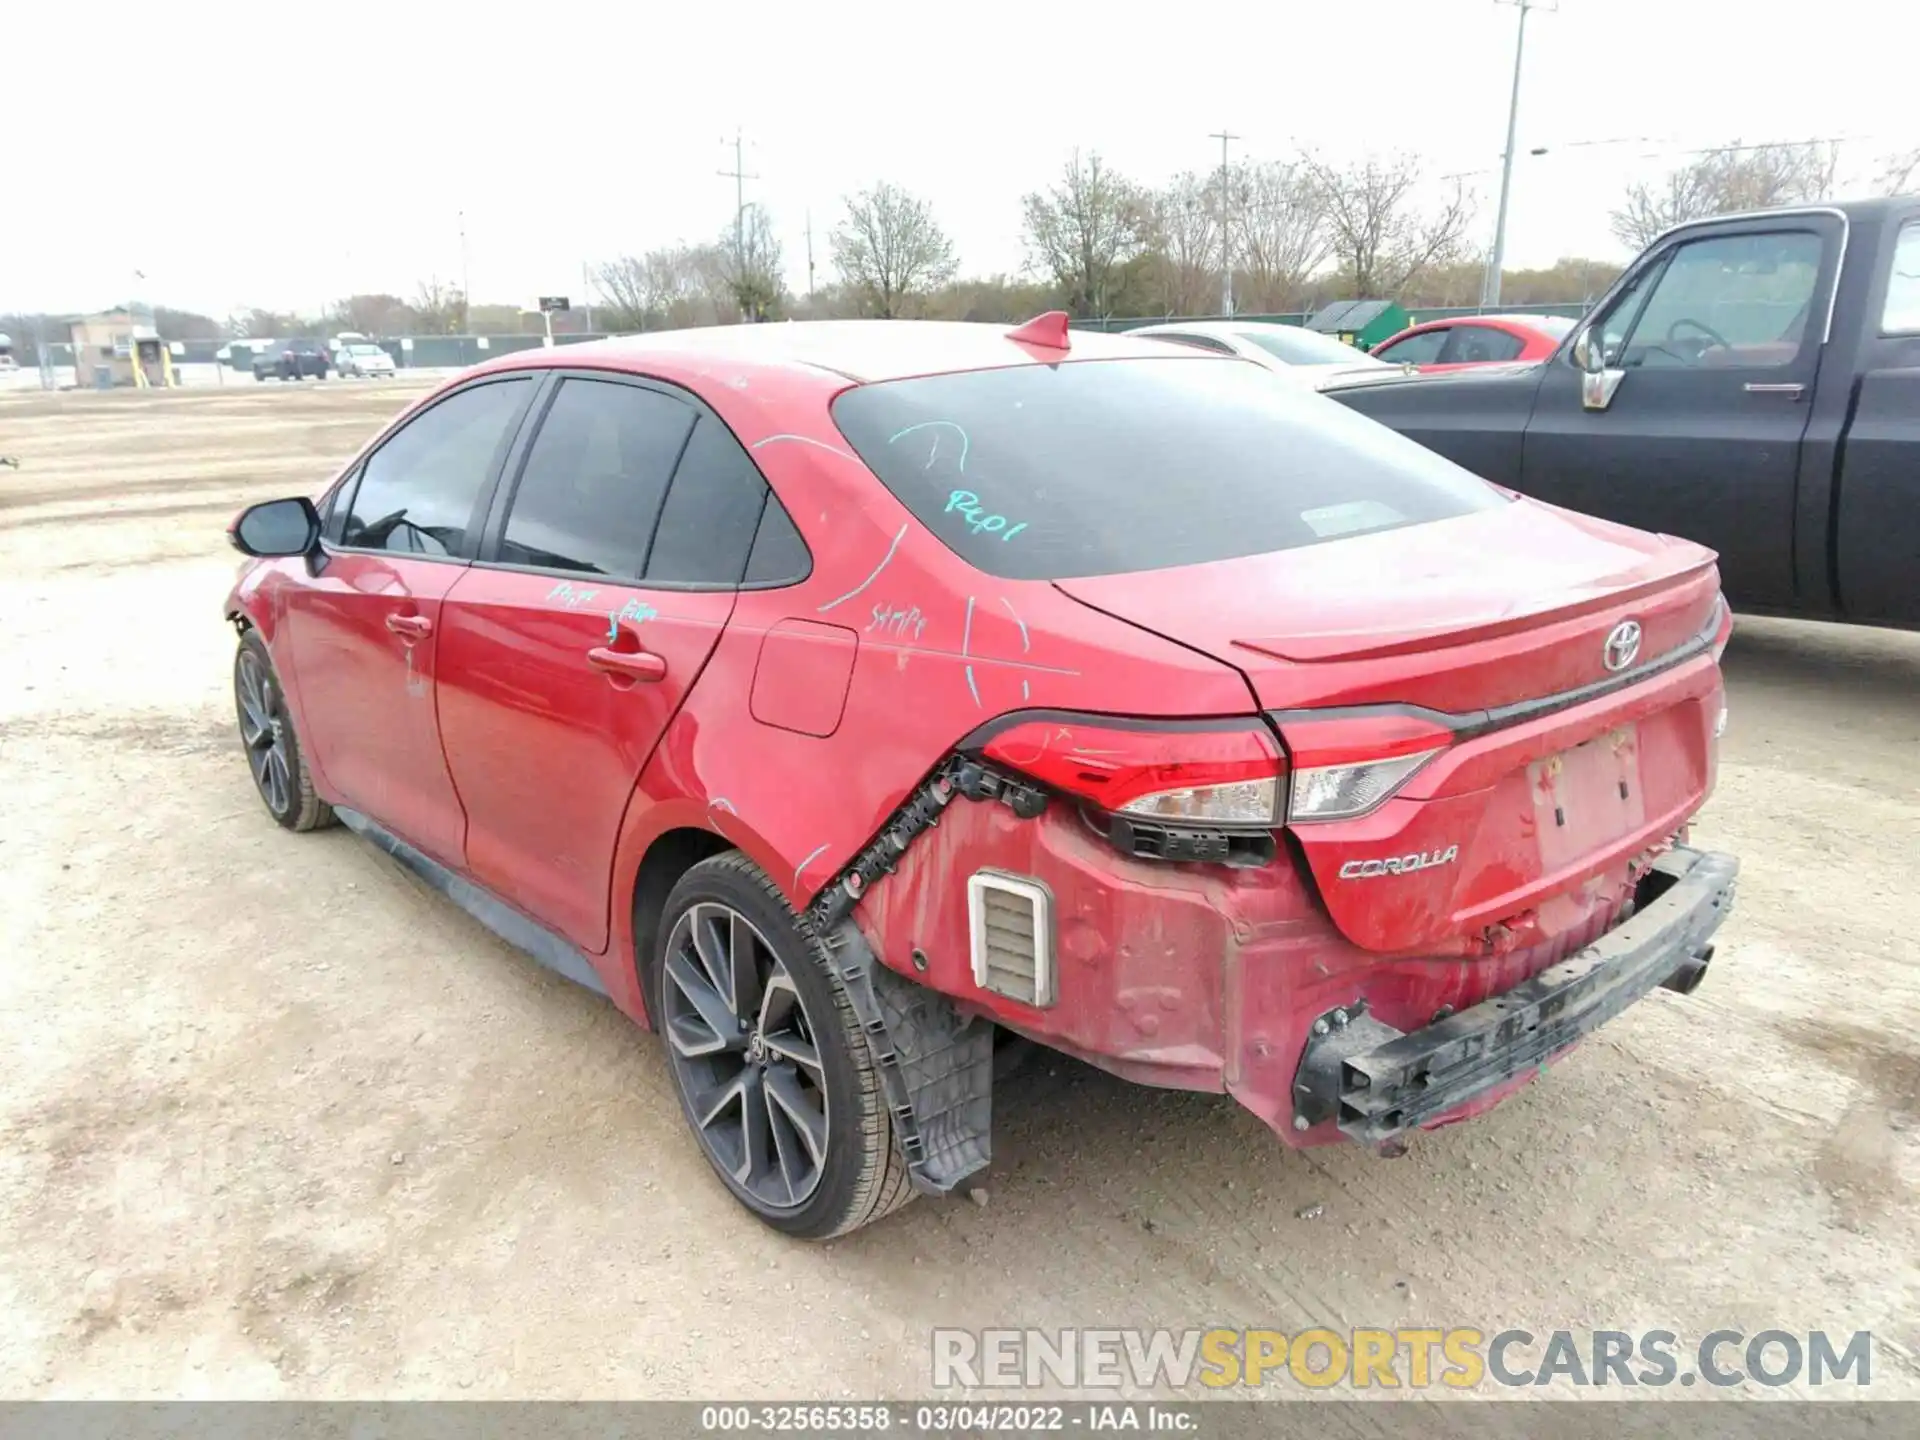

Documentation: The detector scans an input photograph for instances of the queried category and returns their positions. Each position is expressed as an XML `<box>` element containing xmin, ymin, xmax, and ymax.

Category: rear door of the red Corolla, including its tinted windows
<box><xmin>440</xmin><ymin>374</ymin><xmax>778</xmax><ymax>952</ymax></box>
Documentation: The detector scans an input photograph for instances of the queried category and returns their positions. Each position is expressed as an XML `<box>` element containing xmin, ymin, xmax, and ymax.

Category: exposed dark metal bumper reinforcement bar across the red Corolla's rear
<box><xmin>1294</xmin><ymin>847</ymin><xmax>1740</xmax><ymax>1146</ymax></box>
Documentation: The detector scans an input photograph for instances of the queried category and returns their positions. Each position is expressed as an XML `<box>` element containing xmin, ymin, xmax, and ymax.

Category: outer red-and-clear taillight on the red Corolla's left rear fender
<box><xmin>983</xmin><ymin>718</ymin><xmax>1286</xmax><ymax>828</ymax></box>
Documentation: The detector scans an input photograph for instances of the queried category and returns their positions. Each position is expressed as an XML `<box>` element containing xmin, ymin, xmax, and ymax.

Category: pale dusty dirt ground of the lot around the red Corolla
<box><xmin>0</xmin><ymin>382</ymin><xmax>1920</xmax><ymax>1398</ymax></box>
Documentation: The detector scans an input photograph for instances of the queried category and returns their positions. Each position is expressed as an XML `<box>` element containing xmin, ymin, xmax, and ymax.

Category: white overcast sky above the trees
<box><xmin>0</xmin><ymin>0</ymin><xmax>1920</xmax><ymax>315</ymax></box>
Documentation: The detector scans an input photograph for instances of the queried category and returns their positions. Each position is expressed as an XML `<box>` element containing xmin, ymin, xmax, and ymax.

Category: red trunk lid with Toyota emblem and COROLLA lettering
<box><xmin>1056</xmin><ymin>499</ymin><xmax>1720</xmax><ymax>954</ymax></box>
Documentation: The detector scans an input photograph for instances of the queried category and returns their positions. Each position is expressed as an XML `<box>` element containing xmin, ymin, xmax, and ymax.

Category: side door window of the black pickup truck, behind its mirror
<box><xmin>1607</xmin><ymin>230</ymin><xmax>1824</xmax><ymax>371</ymax></box>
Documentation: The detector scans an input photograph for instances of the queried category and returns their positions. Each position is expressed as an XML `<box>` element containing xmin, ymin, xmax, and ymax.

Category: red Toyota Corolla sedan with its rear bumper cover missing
<box><xmin>227</xmin><ymin>315</ymin><xmax>1736</xmax><ymax>1236</ymax></box>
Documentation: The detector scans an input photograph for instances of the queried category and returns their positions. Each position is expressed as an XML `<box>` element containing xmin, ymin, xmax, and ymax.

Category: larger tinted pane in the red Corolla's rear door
<box><xmin>499</xmin><ymin>380</ymin><xmax>695</xmax><ymax>580</ymax></box>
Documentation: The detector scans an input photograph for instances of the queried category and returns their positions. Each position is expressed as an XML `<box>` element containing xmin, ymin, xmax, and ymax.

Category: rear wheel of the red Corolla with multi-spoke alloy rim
<box><xmin>649</xmin><ymin>852</ymin><xmax>914</xmax><ymax>1240</ymax></box>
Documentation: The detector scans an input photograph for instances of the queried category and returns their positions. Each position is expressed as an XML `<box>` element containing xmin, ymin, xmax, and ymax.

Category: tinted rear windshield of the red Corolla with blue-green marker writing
<box><xmin>833</xmin><ymin>355</ymin><xmax>1507</xmax><ymax>580</ymax></box>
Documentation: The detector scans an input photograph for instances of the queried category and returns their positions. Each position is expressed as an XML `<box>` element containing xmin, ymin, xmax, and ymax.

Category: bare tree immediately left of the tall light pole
<box><xmin>1300</xmin><ymin>156</ymin><xmax>1473</xmax><ymax>300</ymax></box>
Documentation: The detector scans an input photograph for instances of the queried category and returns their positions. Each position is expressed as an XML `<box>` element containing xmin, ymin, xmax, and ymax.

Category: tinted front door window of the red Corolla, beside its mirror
<box><xmin>340</xmin><ymin>376</ymin><xmax>534</xmax><ymax>555</ymax></box>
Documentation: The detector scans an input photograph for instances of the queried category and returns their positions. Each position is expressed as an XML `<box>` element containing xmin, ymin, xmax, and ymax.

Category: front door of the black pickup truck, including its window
<box><xmin>1519</xmin><ymin>215</ymin><xmax>1839</xmax><ymax>607</ymax></box>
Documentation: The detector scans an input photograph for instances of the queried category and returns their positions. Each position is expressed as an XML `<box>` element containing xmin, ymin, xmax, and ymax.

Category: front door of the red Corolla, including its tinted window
<box><xmin>284</xmin><ymin>376</ymin><xmax>538</xmax><ymax>866</ymax></box>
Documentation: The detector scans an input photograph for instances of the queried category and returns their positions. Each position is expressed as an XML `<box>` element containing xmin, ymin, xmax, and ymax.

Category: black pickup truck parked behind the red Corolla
<box><xmin>1325</xmin><ymin>196</ymin><xmax>1920</xmax><ymax>628</ymax></box>
